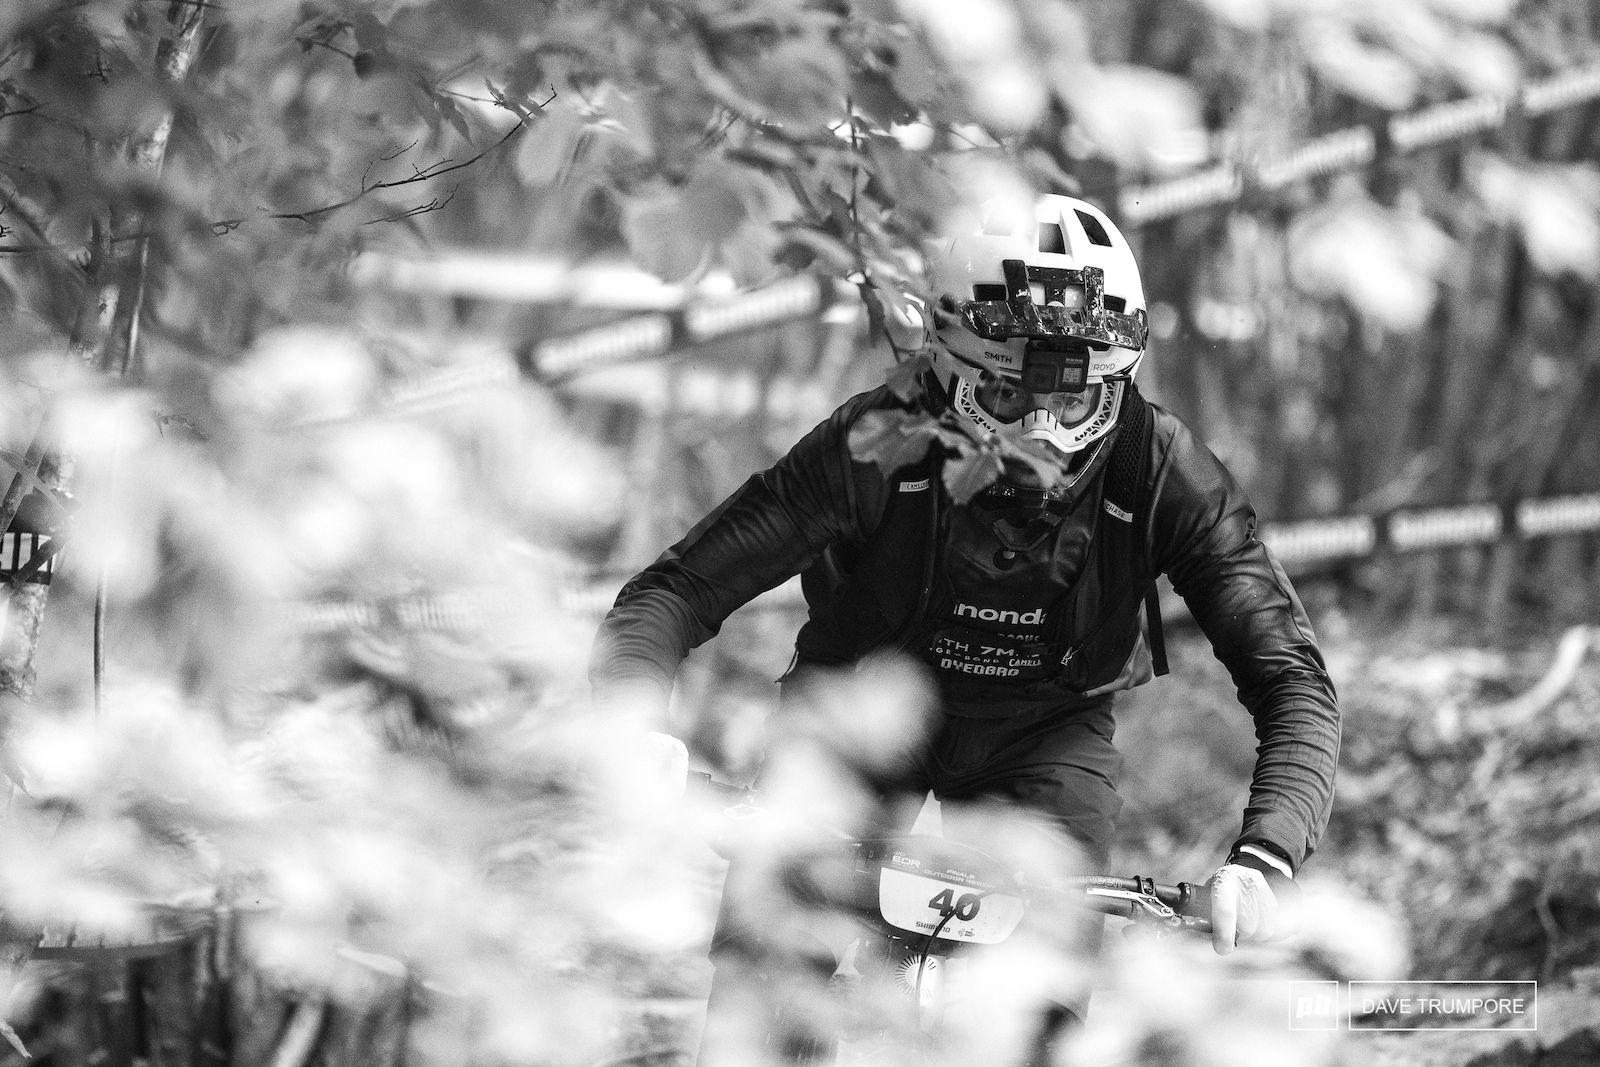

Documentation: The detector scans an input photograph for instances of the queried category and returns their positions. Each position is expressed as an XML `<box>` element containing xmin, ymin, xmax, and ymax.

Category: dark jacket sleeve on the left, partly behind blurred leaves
<box><xmin>589</xmin><ymin>405</ymin><xmax>858</xmax><ymax>712</ymax></box>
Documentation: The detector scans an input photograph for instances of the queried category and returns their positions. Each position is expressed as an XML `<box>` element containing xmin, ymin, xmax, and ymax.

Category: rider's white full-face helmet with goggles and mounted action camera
<box><xmin>931</xmin><ymin>195</ymin><xmax>1147</xmax><ymax>459</ymax></box>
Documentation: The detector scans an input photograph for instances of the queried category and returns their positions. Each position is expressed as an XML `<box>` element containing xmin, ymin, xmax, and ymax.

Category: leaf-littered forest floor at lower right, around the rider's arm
<box><xmin>1114</xmin><ymin>616</ymin><xmax>1600</xmax><ymax>1067</ymax></box>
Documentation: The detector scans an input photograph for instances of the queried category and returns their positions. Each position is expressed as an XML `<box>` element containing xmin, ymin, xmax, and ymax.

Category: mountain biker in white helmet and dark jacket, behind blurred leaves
<box><xmin>590</xmin><ymin>195</ymin><xmax>1339</xmax><ymax>1062</ymax></box>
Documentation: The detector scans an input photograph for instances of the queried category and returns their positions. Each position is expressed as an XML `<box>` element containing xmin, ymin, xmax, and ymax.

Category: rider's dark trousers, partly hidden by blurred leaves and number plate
<box><xmin>701</xmin><ymin>675</ymin><xmax>1122</xmax><ymax>1067</ymax></box>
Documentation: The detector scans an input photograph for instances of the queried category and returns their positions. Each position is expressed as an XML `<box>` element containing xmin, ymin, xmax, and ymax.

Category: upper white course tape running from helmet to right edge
<box><xmin>1117</xmin><ymin>64</ymin><xmax>1600</xmax><ymax>227</ymax></box>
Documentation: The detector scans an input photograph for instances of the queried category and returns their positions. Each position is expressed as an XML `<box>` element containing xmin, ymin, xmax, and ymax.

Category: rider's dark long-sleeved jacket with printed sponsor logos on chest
<box><xmin>590</xmin><ymin>387</ymin><xmax>1339</xmax><ymax>870</ymax></box>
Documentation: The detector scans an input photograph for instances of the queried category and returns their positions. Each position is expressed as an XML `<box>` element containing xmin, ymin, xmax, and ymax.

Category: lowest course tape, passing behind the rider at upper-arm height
<box><xmin>290</xmin><ymin>493</ymin><xmax>1600</xmax><ymax>635</ymax></box>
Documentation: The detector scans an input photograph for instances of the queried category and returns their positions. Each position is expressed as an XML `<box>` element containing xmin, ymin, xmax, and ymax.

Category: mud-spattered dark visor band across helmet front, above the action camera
<box><xmin>955</xmin><ymin>259</ymin><xmax>1149</xmax><ymax>350</ymax></box>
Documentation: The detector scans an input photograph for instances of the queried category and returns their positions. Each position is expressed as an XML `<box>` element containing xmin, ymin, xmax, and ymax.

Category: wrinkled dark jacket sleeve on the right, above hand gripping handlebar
<box><xmin>1150</xmin><ymin>414</ymin><xmax>1339</xmax><ymax>870</ymax></box>
